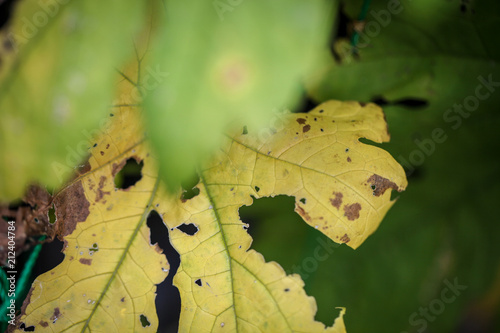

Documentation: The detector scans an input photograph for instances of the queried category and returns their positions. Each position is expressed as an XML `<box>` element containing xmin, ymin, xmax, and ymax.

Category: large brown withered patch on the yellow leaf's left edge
<box><xmin>54</xmin><ymin>180</ymin><xmax>90</xmax><ymax>240</ymax></box>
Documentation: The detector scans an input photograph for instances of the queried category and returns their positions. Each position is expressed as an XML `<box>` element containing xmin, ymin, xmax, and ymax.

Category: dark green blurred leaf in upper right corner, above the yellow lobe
<box><xmin>309</xmin><ymin>0</ymin><xmax>500</xmax><ymax>107</ymax></box>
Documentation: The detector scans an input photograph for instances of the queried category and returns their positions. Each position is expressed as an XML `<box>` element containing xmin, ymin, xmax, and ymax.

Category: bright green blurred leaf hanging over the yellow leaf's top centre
<box><xmin>145</xmin><ymin>0</ymin><xmax>333</xmax><ymax>189</ymax></box>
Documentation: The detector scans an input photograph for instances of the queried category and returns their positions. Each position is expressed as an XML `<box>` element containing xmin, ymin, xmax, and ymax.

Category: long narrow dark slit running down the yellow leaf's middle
<box><xmin>146</xmin><ymin>210</ymin><xmax>181</xmax><ymax>332</ymax></box>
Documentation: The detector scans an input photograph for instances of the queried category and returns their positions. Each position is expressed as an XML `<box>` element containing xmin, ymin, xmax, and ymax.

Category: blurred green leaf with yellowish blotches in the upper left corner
<box><xmin>0</xmin><ymin>0</ymin><xmax>145</xmax><ymax>200</ymax></box>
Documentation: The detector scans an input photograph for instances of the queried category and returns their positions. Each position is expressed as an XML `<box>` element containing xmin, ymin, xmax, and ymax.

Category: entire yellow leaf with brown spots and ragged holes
<box><xmin>14</xmin><ymin>95</ymin><xmax>406</xmax><ymax>333</ymax></box>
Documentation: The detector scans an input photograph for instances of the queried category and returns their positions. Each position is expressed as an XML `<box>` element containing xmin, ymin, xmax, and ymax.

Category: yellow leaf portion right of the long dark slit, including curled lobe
<box><xmin>155</xmin><ymin>101</ymin><xmax>406</xmax><ymax>332</ymax></box>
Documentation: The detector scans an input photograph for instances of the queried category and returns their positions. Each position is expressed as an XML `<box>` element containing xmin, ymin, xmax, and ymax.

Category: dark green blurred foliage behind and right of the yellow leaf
<box><xmin>244</xmin><ymin>0</ymin><xmax>500</xmax><ymax>333</ymax></box>
